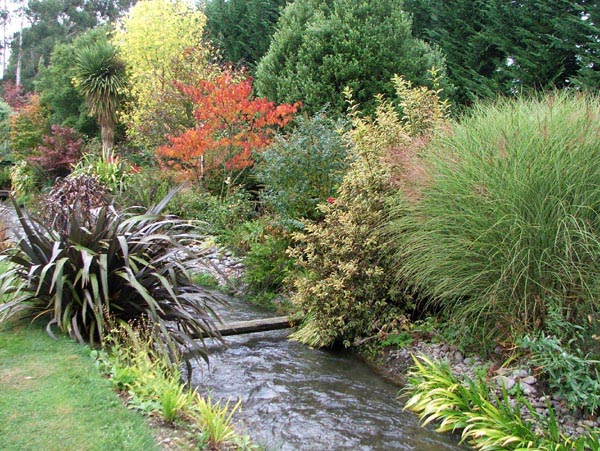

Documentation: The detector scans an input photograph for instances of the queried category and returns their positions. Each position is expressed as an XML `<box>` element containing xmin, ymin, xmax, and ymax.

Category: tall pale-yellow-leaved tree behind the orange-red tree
<box><xmin>114</xmin><ymin>0</ymin><xmax>217</xmax><ymax>146</ymax></box>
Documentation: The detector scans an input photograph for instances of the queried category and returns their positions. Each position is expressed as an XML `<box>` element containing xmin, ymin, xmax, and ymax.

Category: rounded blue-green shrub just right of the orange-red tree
<box><xmin>255</xmin><ymin>112</ymin><xmax>348</xmax><ymax>223</ymax></box>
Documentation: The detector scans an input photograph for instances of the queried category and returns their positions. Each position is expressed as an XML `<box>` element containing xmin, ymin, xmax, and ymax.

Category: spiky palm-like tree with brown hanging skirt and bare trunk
<box><xmin>75</xmin><ymin>42</ymin><xmax>125</xmax><ymax>158</ymax></box>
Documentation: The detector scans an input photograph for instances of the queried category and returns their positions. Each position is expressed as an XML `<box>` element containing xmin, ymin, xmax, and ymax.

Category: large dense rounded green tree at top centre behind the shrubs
<box><xmin>256</xmin><ymin>0</ymin><xmax>445</xmax><ymax>115</ymax></box>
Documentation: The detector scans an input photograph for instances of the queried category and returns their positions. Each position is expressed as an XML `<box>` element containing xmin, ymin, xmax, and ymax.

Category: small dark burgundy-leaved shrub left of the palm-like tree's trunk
<box><xmin>28</xmin><ymin>125</ymin><xmax>83</xmax><ymax>177</ymax></box>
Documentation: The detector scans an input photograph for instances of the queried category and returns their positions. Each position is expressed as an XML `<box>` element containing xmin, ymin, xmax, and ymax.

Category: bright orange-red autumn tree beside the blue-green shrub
<box><xmin>157</xmin><ymin>73</ymin><xmax>299</xmax><ymax>192</ymax></box>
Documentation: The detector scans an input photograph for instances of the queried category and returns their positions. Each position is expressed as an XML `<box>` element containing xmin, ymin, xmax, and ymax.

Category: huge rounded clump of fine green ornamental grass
<box><xmin>389</xmin><ymin>93</ymin><xmax>600</xmax><ymax>343</ymax></box>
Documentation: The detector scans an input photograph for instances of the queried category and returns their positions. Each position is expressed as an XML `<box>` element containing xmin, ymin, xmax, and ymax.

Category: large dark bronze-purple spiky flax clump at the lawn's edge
<box><xmin>0</xmin><ymin>187</ymin><xmax>221</xmax><ymax>357</ymax></box>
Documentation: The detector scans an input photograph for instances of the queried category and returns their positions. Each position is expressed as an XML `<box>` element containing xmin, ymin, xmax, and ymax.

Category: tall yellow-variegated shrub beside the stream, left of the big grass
<box><xmin>290</xmin><ymin>77</ymin><xmax>445</xmax><ymax>346</ymax></box>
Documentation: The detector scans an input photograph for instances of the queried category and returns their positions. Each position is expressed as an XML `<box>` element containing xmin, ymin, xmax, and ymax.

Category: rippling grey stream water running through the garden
<box><xmin>192</xmin><ymin>300</ymin><xmax>462</xmax><ymax>451</ymax></box>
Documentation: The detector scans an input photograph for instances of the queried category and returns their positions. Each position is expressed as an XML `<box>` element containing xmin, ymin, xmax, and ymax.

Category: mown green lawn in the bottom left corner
<box><xmin>0</xmin><ymin>323</ymin><xmax>159</xmax><ymax>450</ymax></box>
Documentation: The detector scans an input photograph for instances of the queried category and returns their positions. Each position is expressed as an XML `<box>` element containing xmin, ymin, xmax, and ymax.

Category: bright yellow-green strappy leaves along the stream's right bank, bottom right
<box><xmin>404</xmin><ymin>356</ymin><xmax>600</xmax><ymax>451</ymax></box>
